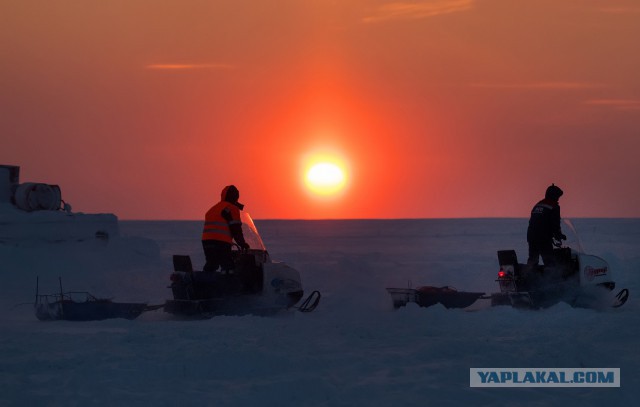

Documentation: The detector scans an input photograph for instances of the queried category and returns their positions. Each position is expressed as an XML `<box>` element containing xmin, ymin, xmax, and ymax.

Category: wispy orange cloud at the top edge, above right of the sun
<box><xmin>362</xmin><ymin>0</ymin><xmax>475</xmax><ymax>23</ymax></box>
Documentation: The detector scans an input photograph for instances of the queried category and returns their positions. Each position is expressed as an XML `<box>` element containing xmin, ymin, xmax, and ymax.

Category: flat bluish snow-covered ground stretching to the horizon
<box><xmin>0</xmin><ymin>219</ymin><xmax>640</xmax><ymax>406</ymax></box>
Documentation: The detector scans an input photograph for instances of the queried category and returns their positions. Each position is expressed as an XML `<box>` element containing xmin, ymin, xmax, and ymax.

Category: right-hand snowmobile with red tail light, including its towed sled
<box><xmin>387</xmin><ymin>231</ymin><xmax>629</xmax><ymax>310</ymax></box>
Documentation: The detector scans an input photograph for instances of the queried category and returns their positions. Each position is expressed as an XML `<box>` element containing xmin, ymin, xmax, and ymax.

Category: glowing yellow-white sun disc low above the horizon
<box><xmin>304</xmin><ymin>156</ymin><xmax>347</xmax><ymax>198</ymax></box>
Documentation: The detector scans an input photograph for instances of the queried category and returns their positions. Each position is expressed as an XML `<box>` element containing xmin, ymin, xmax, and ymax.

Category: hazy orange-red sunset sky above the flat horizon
<box><xmin>0</xmin><ymin>0</ymin><xmax>640</xmax><ymax>219</ymax></box>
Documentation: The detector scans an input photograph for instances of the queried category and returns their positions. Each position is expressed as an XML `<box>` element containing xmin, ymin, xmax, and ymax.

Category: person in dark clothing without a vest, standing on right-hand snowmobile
<box><xmin>527</xmin><ymin>184</ymin><xmax>567</xmax><ymax>266</ymax></box>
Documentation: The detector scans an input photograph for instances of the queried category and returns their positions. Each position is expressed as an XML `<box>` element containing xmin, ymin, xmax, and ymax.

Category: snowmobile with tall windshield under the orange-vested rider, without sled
<box><xmin>164</xmin><ymin>212</ymin><xmax>321</xmax><ymax>318</ymax></box>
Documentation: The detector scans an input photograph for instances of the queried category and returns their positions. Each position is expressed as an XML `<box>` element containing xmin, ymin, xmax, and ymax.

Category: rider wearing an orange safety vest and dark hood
<box><xmin>202</xmin><ymin>185</ymin><xmax>249</xmax><ymax>271</ymax></box>
